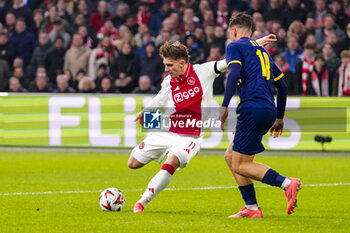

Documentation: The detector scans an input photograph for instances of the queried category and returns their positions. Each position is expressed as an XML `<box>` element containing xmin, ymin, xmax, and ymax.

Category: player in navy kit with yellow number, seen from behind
<box><xmin>220</xmin><ymin>13</ymin><xmax>301</xmax><ymax>218</ymax></box>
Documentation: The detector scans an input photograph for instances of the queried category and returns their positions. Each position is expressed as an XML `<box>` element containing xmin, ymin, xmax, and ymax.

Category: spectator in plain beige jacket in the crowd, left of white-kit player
<box><xmin>63</xmin><ymin>34</ymin><xmax>91</xmax><ymax>79</ymax></box>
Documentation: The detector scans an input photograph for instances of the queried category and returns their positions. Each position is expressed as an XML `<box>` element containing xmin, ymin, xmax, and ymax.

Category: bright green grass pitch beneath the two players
<box><xmin>0</xmin><ymin>152</ymin><xmax>350</xmax><ymax>233</ymax></box>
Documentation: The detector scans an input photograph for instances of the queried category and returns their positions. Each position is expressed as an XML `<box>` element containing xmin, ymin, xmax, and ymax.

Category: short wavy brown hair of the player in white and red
<box><xmin>159</xmin><ymin>41</ymin><xmax>190</xmax><ymax>62</ymax></box>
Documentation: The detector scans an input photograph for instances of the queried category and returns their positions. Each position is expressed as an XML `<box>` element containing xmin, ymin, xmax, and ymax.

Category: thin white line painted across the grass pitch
<box><xmin>0</xmin><ymin>183</ymin><xmax>350</xmax><ymax>196</ymax></box>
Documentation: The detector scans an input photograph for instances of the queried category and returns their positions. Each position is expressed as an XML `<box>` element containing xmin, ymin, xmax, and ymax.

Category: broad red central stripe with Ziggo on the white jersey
<box><xmin>169</xmin><ymin>64</ymin><xmax>203</xmax><ymax>136</ymax></box>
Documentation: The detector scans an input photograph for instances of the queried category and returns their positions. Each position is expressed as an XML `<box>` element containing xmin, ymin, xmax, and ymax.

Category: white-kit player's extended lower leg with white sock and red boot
<box><xmin>133</xmin><ymin>155</ymin><xmax>180</xmax><ymax>213</ymax></box>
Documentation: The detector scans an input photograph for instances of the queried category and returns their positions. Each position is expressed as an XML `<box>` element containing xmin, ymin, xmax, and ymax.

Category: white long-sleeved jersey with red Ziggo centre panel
<box><xmin>148</xmin><ymin>60</ymin><xmax>227</xmax><ymax>136</ymax></box>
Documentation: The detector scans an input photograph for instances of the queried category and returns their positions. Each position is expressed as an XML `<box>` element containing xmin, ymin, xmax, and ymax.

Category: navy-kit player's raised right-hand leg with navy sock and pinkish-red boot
<box><xmin>231</xmin><ymin>151</ymin><xmax>301</xmax><ymax>214</ymax></box>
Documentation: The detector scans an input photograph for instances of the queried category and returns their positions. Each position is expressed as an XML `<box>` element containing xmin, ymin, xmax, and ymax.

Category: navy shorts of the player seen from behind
<box><xmin>232</xmin><ymin>108</ymin><xmax>276</xmax><ymax>155</ymax></box>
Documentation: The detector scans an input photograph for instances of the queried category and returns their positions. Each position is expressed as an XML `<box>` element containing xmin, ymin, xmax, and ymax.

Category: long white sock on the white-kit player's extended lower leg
<box><xmin>138</xmin><ymin>169</ymin><xmax>172</xmax><ymax>206</ymax></box>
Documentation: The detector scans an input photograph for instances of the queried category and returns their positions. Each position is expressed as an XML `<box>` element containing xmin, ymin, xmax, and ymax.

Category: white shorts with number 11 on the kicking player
<box><xmin>131</xmin><ymin>132</ymin><xmax>202</xmax><ymax>169</ymax></box>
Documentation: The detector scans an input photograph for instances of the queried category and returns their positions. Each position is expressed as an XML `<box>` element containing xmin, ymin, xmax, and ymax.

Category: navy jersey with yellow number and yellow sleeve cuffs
<box><xmin>226</xmin><ymin>37</ymin><xmax>283</xmax><ymax>110</ymax></box>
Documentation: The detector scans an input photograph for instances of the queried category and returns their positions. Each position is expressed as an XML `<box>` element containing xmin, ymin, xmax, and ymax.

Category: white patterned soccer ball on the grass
<box><xmin>98</xmin><ymin>188</ymin><xmax>125</xmax><ymax>211</ymax></box>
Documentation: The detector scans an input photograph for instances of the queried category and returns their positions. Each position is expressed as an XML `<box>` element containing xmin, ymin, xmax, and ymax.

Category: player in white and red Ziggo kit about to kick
<box><xmin>128</xmin><ymin>35</ymin><xmax>276</xmax><ymax>213</ymax></box>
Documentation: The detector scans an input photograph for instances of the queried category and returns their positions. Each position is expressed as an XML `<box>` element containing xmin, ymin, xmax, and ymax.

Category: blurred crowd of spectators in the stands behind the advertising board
<box><xmin>0</xmin><ymin>0</ymin><xmax>350</xmax><ymax>96</ymax></box>
